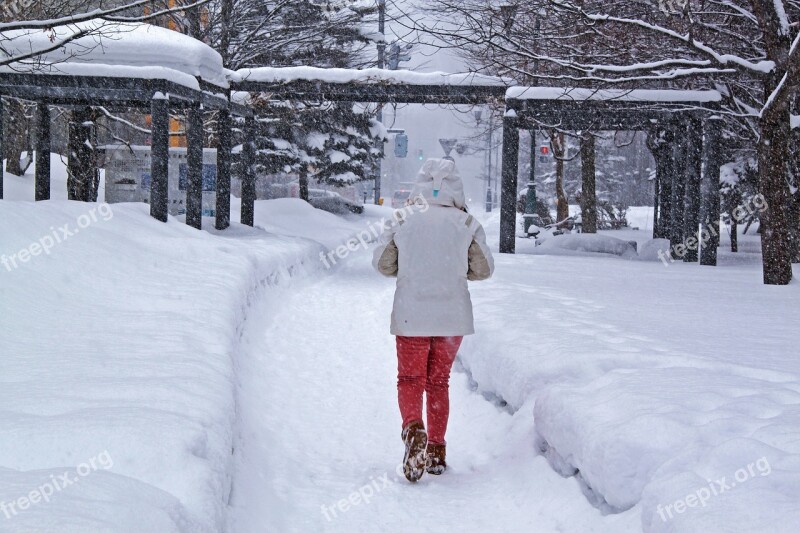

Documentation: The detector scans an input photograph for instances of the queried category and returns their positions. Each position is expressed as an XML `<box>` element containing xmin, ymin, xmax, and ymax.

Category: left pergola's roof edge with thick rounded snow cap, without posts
<box><xmin>0</xmin><ymin>19</ymin><xmax>250</xmax><ymax>112</ymax></box>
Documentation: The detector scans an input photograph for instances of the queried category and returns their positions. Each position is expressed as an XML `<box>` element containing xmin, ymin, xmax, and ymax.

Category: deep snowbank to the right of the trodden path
<box><xmin>460</xmin><ymin>212</ymin><xmax>800</xmax><ymax>533</ymax></box>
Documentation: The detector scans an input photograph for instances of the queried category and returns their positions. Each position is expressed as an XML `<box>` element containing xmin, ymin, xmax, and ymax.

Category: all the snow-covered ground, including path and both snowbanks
<box><xmin>0</xmin><ymin>157</ymin><xmax>800</xmax><ymax>533</ymax></box>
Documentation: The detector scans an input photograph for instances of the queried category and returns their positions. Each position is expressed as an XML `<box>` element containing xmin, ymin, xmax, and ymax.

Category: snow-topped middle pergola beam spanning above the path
<box><xmin>230</xmin><ymin>67</ymin><xmax>513</xmax><ymax>104</ymax></box>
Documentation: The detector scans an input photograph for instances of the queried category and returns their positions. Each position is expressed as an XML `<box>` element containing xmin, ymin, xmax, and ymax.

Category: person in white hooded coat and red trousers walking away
<box><xmin>373</xmin><ymin>159</ymin><xmax>494</xmax><ymax>482</ymax></box>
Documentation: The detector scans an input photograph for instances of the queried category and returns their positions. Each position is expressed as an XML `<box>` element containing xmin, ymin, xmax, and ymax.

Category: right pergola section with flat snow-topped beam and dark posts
<box><xmin>500</xmin><ymin>87</ymin><xmax>722</xmax><ymax>265</ymax></box>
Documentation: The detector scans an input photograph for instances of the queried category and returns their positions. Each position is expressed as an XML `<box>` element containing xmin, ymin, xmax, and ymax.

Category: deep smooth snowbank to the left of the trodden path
<box><xmin>0</xmin><ymin>200</ymin><xmax>363</xmax><ymax>532</ymax></box>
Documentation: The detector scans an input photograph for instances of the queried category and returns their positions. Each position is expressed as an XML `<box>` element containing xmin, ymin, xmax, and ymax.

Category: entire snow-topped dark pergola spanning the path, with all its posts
<box><xmin>0</xmin><ymin>23</ymin><xmax>732</xmax><ymax>265</ymax></box>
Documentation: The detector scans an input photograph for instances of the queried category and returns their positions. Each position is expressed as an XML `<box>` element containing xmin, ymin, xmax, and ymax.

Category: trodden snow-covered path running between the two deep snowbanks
<box><xmin>230</xmin><ymin>251</ymin><xmax>641</xmax><ymax>533</ymax></box>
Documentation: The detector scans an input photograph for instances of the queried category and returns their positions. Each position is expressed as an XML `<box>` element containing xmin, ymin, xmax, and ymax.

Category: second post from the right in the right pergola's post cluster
<box><xmin>683</xmin><ymin>116</ymin><xmax>703</xmax><ymax>263</ymax></box>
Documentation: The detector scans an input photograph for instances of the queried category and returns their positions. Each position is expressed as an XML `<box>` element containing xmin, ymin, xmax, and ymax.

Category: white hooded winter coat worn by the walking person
<box><xmin>373</xmin><ymin>159</ymin><xmax>494</xmax><ymax>337</ymax></box>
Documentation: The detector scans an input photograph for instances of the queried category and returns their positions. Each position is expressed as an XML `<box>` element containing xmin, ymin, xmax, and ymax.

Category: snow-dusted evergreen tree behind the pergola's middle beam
<box><xmin>212</xmin><ymin>0</ymin><xmax>383</xmax><ymax>198</ymax></box>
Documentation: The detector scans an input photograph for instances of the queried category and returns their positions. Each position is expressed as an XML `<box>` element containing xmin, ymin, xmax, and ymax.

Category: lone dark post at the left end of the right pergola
<box><xmin>500</xmin><ymin>110</ymin><xmax>519</xmax><ymax>254</ymax></box>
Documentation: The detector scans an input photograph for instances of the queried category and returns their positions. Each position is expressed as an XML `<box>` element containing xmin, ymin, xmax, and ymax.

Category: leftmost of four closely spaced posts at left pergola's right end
<box><xmin>150</xmin><ymin>93</ymin><xmax>169</xmax><ymax>222</ymax></box>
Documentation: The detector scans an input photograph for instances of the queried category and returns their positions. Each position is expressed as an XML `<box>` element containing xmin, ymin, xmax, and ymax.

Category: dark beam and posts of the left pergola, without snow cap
<box><xmin>0</xmin><ymin>72</ymin><xmax>252</xmax><ymax>229</ymax></box>
